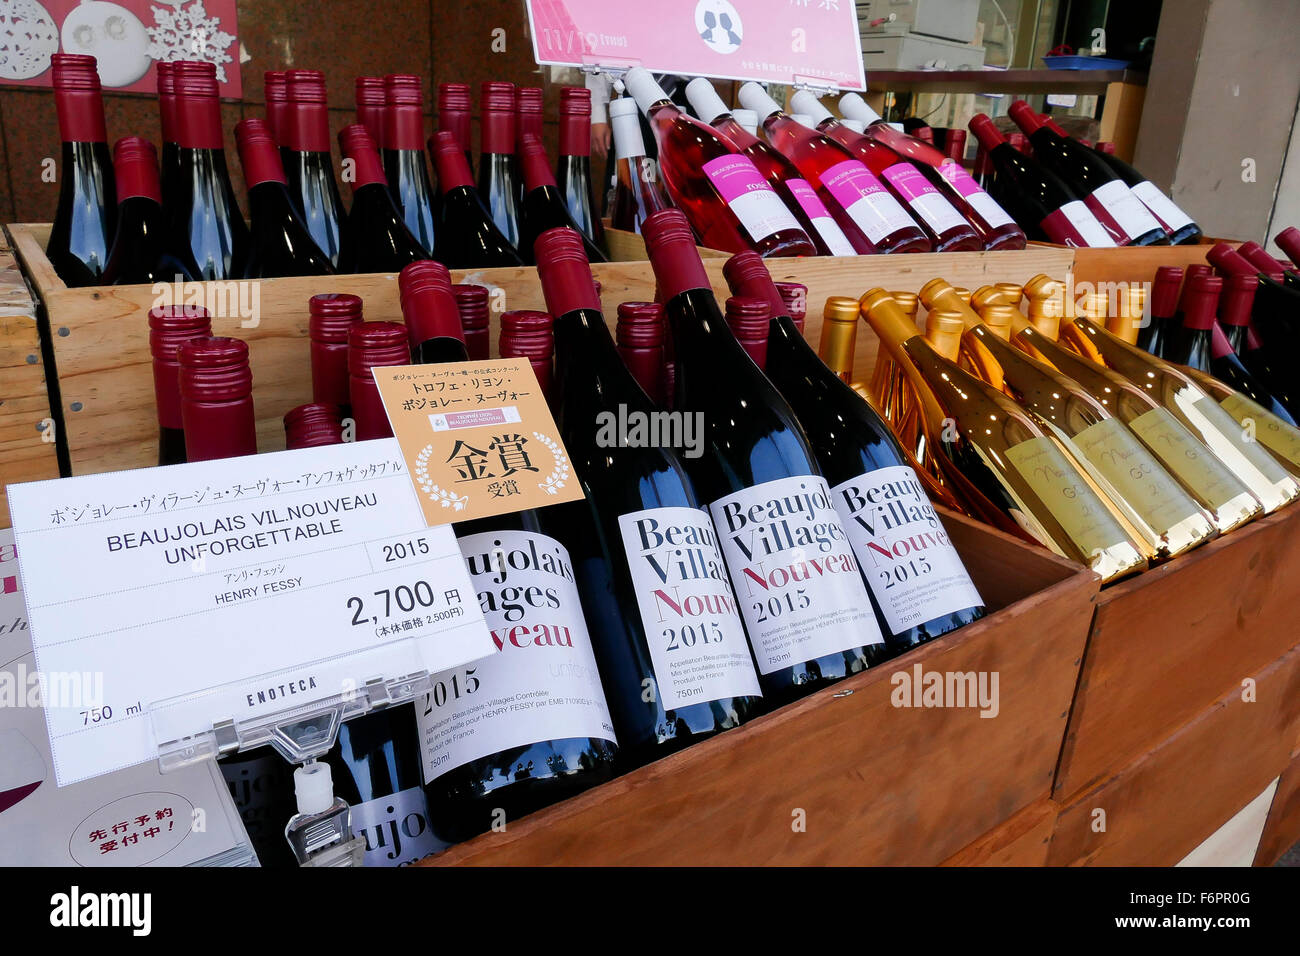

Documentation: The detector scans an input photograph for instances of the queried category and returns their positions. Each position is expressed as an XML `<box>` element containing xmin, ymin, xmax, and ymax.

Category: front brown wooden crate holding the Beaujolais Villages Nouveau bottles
<box><xmin>426</xmin><ymin>515</ymin><xmax>1097</xmax><ymax>865</ymax></box>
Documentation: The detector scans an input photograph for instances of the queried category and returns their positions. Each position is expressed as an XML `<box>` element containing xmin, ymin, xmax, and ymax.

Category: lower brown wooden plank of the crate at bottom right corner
<box><xmin>1048</xmin><ymin>642</ymin><xmax>1300</xmax><ymax>866</ymax></box>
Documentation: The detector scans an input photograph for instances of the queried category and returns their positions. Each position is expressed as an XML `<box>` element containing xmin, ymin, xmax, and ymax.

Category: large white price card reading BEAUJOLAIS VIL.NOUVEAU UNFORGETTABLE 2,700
<box><xmin>8</xmin><ymin>440</ymin><xmax>495</xmax><ymax>787</ymax></box>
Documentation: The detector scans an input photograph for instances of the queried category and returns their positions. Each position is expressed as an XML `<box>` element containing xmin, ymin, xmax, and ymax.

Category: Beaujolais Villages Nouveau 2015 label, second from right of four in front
<box><xmin>709</xmin><ymin>475</ymin><xmax>884</xmax><ymax>674</ymax></box>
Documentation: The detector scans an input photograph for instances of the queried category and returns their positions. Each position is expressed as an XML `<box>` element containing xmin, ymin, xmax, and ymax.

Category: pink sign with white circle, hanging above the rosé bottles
<box><xmin>527</xmin><ymin>0</ymin><xmax>866</xmax><ymax>90</ymax></box>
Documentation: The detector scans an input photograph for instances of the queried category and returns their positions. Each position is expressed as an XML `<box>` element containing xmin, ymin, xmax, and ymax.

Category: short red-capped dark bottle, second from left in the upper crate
<box><xmin>99</xmin><ymin>137</ymin><xmax>198</xmax><ymax>285</ymax></box>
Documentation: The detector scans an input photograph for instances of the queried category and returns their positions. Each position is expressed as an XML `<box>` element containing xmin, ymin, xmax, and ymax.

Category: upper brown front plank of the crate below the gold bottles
<box><xmin>1053</xmin><ymin>507</ymin><xmax>1300</xmax><ymax>801</ymax></box>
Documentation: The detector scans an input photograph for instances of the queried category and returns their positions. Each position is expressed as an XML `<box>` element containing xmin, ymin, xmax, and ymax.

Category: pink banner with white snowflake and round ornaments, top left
<box><xmin>0</xmin><ymin>0</ymin><xmax>242</xmax><ymax>99</ymax></box>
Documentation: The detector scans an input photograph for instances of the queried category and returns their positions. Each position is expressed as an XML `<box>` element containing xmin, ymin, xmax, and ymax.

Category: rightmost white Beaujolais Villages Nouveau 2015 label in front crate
<box><xmin>831</xmin><ymin>464</ymin><xmax>984</xmax><ymax>633</ymax></box>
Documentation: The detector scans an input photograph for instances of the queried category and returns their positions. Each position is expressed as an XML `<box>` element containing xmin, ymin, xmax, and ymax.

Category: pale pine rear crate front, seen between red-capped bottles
<box><xmin>10</xmin><ymin>225</ymin><xmax>1073</xmax><ymax>475</ymax></box>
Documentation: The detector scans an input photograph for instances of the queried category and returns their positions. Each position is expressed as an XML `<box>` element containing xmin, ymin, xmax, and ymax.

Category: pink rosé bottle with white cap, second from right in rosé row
<box><xmin>774</xmin><ymin>90</ymin><xmax>984</xmax><ymax>252</ymax></box>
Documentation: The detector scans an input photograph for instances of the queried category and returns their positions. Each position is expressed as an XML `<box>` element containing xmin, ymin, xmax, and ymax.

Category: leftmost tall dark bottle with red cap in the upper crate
<box><xmin>46</xmin><ymin>53</ymin><xmax>117</xmax><ymax>286</ymax></box>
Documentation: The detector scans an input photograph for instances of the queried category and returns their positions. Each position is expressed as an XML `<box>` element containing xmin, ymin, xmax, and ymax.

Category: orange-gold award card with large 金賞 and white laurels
<box><xmin>373</xmin><ymin>359</ymin><xmax>582</xmax><ymax>525</ymax></box>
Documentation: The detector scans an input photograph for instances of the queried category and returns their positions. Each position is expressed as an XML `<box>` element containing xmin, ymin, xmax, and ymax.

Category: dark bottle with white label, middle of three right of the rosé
<box><xmin>1008</xmin><ymin>100</ymin><xmax>1169</xmax><ymax>246</ymax></box>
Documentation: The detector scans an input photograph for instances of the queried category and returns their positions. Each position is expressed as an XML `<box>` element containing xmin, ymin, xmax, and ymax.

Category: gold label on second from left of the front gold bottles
<box><xmin>1074</xmin><ymin>419</ymin><xmax>1200</xmax><ymax>535</ymax></box>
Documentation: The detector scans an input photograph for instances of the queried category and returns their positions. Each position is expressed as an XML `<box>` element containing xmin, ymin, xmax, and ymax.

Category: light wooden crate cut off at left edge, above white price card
<box><xmin>0</xmin><ymin>239</ymin><xmax>59</xmax><ymax>528</ymax></box>
